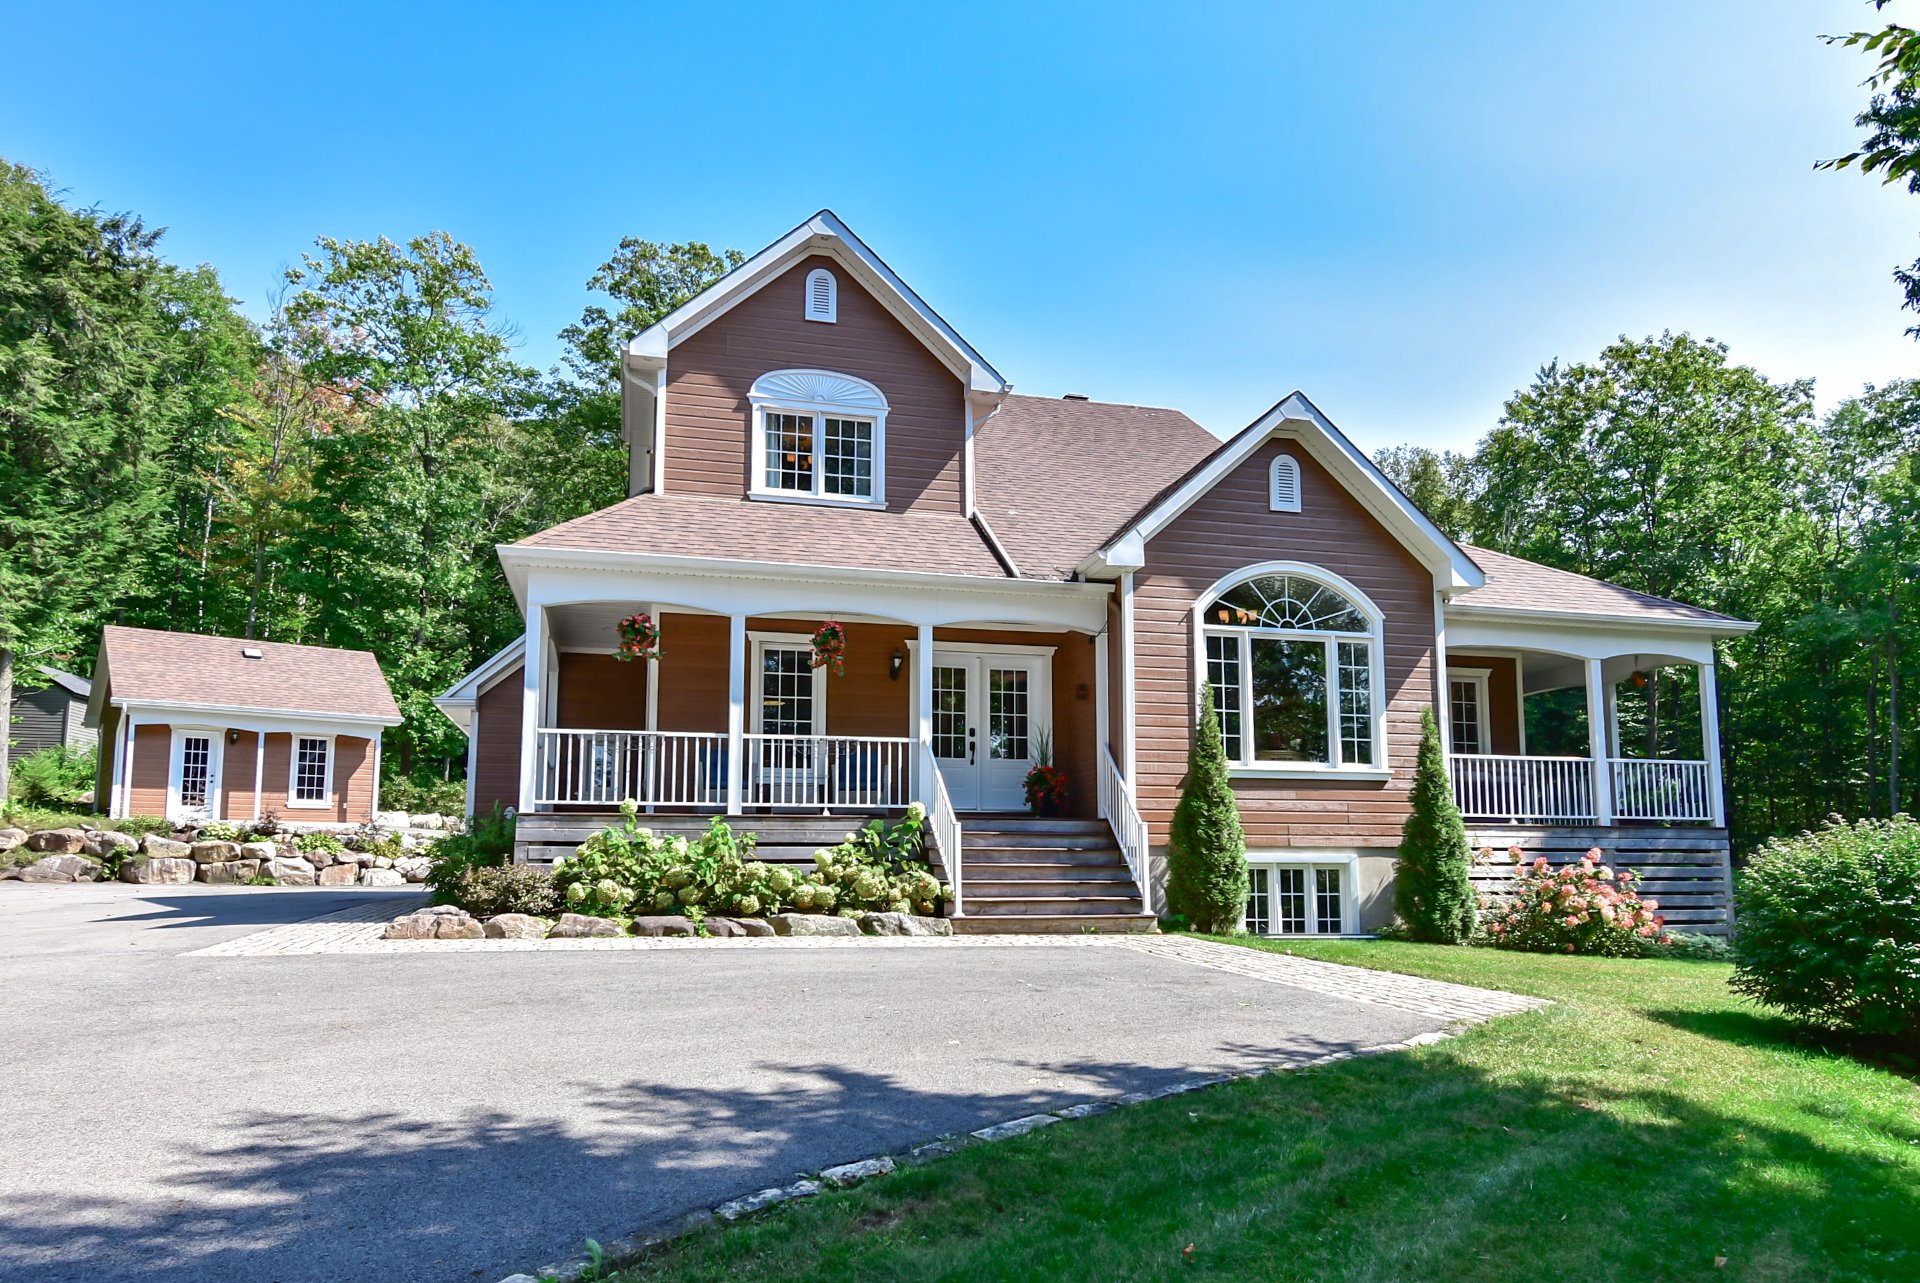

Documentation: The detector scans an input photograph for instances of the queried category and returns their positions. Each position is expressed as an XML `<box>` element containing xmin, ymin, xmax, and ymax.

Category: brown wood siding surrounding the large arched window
<box><xmin>1135</xmin><ymin>442</ymin><xmax>1434</xmax><ymax>849</ymax></box>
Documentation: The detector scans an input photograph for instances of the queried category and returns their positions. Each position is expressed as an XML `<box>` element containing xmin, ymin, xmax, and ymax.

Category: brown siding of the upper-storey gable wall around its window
<box><xmin>666</xmin><ymin>255</ymin><xmax>966</xmax><ymax>513</ymax></box>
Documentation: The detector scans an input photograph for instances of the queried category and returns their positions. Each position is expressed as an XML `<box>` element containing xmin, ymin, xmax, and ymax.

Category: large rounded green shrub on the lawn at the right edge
<box><xmin>1732</xmin><ymin>816</ymin><xmax>1920</xmax><ymax>1043</ymax></box>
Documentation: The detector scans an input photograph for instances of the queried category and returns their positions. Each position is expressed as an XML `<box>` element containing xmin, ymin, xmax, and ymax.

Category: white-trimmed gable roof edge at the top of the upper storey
<box><xmin>626</xmin><ymin>209</ymin><xmax>1012</xmax><ymax>396</ymax></box>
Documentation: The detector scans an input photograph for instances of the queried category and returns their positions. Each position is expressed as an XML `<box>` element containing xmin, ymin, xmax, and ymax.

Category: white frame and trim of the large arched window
<box><xmin>1190</xmin><ymin>561</ymin><xmax>1394</xmax><ymax>780</ymax></box>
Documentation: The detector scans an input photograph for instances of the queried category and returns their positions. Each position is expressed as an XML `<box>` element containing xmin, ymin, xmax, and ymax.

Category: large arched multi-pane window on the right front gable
<box><xmin>1200</xmin><ymin>565</ymin><xmax>1382</xmax><ymax>770</ymax></box>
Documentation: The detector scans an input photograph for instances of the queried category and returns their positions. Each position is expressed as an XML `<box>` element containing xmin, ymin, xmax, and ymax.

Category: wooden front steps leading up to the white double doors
<box><xmin>954</xmin><ymin>816</ymin><xmax>1156</xmax><ymax>935</ymax></box>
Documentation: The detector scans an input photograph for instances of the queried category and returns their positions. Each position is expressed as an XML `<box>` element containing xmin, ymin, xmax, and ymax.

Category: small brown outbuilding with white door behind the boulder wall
<box><xmin>86</xmin><ymin>628</ymin><xmax>401</xmax><ymax>824</ymax></box>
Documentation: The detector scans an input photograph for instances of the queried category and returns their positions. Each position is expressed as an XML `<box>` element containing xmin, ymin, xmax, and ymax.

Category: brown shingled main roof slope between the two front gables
<box><xmin>973</xmin><ymin>396</ymin><xmax>1221</xmax><ymax>580</ymax></box>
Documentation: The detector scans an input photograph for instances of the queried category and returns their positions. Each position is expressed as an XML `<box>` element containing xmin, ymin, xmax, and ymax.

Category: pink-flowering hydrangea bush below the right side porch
<box><xmin>1486</xmin><ymin>847</ymin><xmax>1672</xmax><ymax>958</ymax></box>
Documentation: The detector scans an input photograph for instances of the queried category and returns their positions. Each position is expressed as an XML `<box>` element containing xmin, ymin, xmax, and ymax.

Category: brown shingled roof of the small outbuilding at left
<box><xmin>100</xmin><ymin>624</ymin><xmax>399</xmax><ymax>722</ymax></box>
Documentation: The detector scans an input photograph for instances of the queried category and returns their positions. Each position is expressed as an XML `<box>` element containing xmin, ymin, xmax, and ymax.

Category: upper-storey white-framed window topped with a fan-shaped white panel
<box><xmin>749</xmin><ymin>371</ymin><xmax>887</xmax><ymax>507</ymax></box>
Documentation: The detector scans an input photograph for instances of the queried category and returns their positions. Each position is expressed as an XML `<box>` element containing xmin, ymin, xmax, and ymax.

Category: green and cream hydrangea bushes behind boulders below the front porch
<box><xmin>553</xmin><ymin>803</ymin><xmax>952</xmax><ymax>918</ymax></box>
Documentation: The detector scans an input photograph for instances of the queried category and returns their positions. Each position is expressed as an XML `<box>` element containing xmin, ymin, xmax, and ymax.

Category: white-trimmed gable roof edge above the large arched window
<box><xmin>1085</xmin><ymin>390</ymin><xmax>1486</xmax><ymax>590</ymax></box>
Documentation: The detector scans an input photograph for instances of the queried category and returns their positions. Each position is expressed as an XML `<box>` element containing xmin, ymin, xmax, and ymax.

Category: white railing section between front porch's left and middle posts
<box><xmin>534</xmin><ymin>730</ymin><xmax>726</xmax><ymax>807</ymax></box>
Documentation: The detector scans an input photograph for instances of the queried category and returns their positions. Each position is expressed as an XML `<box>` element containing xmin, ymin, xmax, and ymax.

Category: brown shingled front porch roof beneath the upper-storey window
<box><xmin>516</xmin><ymin>494</ymin><xmax>1006</xmax><ymax>578</ymax></box>
